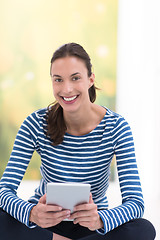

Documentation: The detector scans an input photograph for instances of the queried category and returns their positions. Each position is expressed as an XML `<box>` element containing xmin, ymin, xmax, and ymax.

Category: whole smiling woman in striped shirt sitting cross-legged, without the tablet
<box><xmin>0</xmin><ymin>43</ymin><xmax>155</xmax><ymax>240</ymax></box>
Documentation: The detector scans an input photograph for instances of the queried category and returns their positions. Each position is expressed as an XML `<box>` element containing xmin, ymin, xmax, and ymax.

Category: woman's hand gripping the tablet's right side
<box><xmin>69</xmin><ymin>193</ymin><xmax>103</xmax><ymax>231</ymax></box>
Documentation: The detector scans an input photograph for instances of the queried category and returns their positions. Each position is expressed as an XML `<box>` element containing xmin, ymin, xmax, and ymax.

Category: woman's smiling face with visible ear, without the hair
<box><xmin>51</xmin><ymin>56</ymin><xmax>94</xmax><ymax>112</ymax></box>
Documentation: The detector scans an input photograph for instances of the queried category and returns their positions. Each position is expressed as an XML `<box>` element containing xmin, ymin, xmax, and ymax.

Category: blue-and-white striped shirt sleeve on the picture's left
<box><xmin>0</xmin><ymin>113</ymin><xmax>39</xmax><ymax>227</ymax></box>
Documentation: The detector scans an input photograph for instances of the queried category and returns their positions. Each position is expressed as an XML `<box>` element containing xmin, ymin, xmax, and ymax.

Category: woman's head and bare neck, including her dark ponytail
<box><xmin>47</xmin><ymin>43</ymin><xmax>99</xmax><ymax>145</ymax></box>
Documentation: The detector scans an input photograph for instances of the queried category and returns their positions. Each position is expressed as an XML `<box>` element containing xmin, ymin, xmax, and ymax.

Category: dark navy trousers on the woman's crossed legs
<box><xmin>0</xmin><ymin>209</ymin><xmax>156</xmax><ymax>240</ymax></box>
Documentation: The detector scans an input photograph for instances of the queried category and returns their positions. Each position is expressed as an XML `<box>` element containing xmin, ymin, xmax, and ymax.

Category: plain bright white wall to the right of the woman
<box><xmin>116</xmin><ymin>0</ymin><xmax>160</xmax><ymax>235</ymax></box>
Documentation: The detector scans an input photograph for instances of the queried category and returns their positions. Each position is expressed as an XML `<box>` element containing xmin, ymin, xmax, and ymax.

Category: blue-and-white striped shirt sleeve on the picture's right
<box><xmin>98</xmin><ymin>117</ymin><xmax>144</xmax><ymax>234</ymax></box>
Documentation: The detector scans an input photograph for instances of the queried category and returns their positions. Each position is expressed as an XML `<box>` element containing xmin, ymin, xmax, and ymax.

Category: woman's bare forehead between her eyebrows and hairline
<box><xmin>51</xmin><ymin>56</ymin><xmax>87</xmax><ymax>74</ymax></box>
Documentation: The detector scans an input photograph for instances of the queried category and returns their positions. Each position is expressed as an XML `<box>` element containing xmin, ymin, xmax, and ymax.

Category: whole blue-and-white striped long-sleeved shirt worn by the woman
<box><xmin>0</xmin><ymin>108</ymin><xmax>144</xmax><ymax>234</ymax></box>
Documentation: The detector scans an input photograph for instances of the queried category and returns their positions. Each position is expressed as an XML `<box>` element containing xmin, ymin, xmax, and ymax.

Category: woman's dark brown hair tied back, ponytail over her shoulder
<box><xmin>47</xmin><ymin>43</ymin><xmax>97</xmax><ymax>146</ymax></box>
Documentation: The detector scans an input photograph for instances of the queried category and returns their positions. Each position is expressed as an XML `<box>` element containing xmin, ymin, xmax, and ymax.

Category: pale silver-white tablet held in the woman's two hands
<box><xmin>46</xmin><ymin>183</ymin><xmax>90</xmax><ymax>213</ymax></box>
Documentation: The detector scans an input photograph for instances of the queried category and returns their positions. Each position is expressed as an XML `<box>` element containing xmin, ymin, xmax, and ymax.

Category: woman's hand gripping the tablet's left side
<box><xmin>29</xmin><ymin>194</ymin><xmax>70</xmax><ymax>228</ymax></box>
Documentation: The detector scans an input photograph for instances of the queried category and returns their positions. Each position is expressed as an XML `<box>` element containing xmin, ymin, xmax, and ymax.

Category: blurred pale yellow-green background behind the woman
<box><xmin>0</xmin><ymin>0</ymin><xmax>118</xmax><ymax>179</ymax></box>
